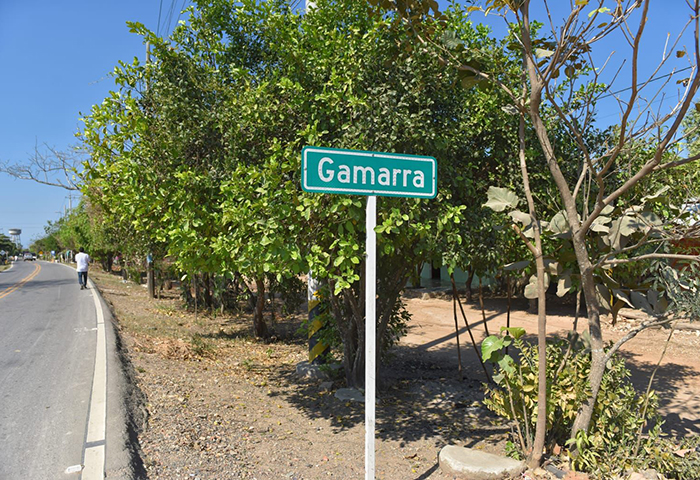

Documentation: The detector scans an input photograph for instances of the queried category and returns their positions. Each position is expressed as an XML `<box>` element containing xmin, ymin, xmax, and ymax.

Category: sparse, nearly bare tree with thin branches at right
<box><xmin>378</xmin><ymin>0</ymin><xmax>700</xmax><ymax>464</ymax></box>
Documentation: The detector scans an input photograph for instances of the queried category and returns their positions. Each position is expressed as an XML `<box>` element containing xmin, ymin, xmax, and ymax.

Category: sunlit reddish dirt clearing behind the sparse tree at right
<box><xmin>403</xmin><ymin>288</ymin><xmax>700</xmax><ymax>436</ymax></box>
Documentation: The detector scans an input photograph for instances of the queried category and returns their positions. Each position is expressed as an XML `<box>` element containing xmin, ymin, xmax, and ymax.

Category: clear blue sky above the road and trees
<box><xmin>0</xmin><ymin>0</ymin><xmax>687</xmax><ymax>246</ymax></box>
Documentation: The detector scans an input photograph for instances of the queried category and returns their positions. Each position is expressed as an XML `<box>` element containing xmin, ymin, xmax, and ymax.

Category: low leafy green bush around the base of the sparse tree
<box><xmin>481</xmin><ymin>328</ymin><xmax>700</xmax><ymax>478</ymax></box>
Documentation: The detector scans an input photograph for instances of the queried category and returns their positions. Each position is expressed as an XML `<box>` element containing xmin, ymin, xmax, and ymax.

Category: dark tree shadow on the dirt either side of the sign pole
<box><xmin>272</xmin><ymin>336</ymin><xmax>509</xmax><ymax>450</ymax></box>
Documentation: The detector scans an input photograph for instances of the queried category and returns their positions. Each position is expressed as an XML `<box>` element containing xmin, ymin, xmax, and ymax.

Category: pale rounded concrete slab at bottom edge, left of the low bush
<box><xmin>438</xmin><ymin>445</ymin><xmax>525</xmax><ymax>480</ymax></box>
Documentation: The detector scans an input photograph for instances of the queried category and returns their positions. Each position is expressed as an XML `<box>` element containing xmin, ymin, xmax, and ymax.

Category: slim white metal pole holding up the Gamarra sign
<box><xmin>365</xmin><ymin>195</ymin><xmax>377</xmax><ymax>480</ymax></box>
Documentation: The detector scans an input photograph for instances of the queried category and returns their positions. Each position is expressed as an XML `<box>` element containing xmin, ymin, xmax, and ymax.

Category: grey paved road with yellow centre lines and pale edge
<box><xmin>0</xmin><ymin>262</ymin><xmax>135</xmax><ymax>480</ymax></box>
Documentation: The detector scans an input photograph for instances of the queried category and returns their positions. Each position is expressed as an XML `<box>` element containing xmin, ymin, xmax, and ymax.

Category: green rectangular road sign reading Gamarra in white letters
<box><xmin>301</xmin><ymin>147</ymin><xmax>437</xmax><ymax>198</ymax></box>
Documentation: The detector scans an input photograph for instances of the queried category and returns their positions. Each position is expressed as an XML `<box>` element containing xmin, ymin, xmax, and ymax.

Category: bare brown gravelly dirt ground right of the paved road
<box><xmin>93</xmin><ymin>273</ymin><xmax>700</xmax><ymax>480</ymax></box>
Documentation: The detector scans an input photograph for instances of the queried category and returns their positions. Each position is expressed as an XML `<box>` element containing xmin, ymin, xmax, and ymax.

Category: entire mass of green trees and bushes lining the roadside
<box><xmin>21</xmin><ymin>0</ymin><xmax>700</xmax><ymax>478</ymax></box>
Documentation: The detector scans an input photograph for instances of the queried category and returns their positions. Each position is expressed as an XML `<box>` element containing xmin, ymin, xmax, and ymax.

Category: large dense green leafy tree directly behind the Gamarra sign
<box><xmin>82</xmin><ymin>0</ymin><xmax>515</xmax><ymax>385</ymax></box>
